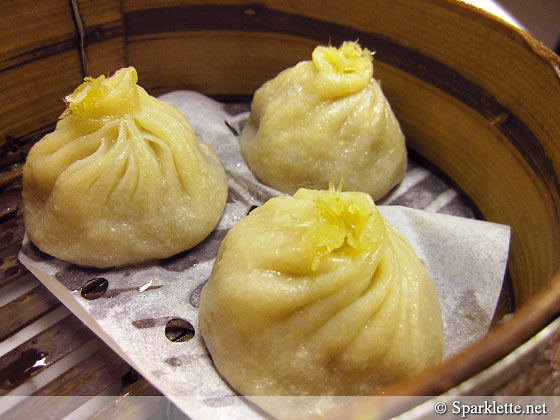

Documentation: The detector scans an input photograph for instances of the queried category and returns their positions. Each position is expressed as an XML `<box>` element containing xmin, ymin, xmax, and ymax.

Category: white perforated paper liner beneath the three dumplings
<box><xmin>19</xmin><ymin>91</ymin><xmax>510</xmax><ymax>419</ymax></box>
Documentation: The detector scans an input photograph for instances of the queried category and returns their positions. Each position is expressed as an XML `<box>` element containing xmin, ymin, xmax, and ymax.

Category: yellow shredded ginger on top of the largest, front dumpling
<box><xmin>294</xmin><ymin>185</ymin><xmax>383</xmax><ymax>271</ymax></box>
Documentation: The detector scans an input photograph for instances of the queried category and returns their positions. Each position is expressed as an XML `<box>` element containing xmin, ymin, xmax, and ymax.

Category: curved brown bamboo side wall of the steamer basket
<box><xmin>0</xmin><ymin>0</ymin><xmax>560</xmax><ymax>414</ymax></box>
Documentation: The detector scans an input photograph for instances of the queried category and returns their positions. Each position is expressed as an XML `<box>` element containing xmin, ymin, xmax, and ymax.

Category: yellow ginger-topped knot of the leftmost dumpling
<box><xmin>60</xmin><ymin>67</ymin><xmax>138</xmax><ymax>119</ymax></box>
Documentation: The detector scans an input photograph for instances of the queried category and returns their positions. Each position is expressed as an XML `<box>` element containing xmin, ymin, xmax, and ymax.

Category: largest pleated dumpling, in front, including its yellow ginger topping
<box><xmin>199</xmin><ymin>189</ymin><xmax>443</xmax><ymax>396</ymax></box>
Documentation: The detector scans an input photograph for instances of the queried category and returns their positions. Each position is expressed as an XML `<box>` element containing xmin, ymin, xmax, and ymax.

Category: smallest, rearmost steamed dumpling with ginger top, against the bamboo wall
<box><xmin>239</xmin><ymin>42</ymin><xmax>406</xmax><ymax>200</ymax></box>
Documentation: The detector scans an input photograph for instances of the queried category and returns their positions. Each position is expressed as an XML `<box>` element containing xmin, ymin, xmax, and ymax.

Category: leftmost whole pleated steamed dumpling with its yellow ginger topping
<box><xmin>23</xmin><ymin>67</ymin><xmax>227</xmax><ymax>267</ymax></box>
